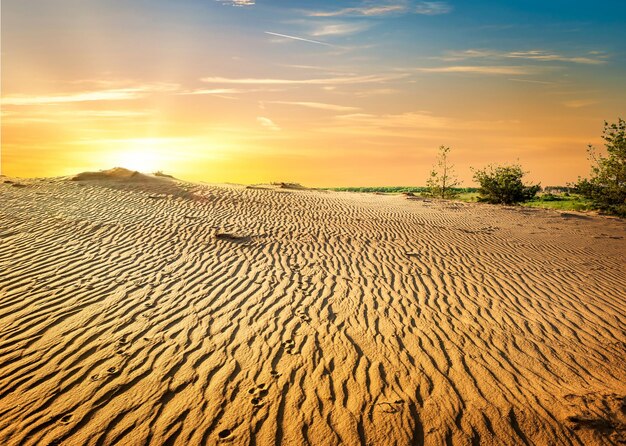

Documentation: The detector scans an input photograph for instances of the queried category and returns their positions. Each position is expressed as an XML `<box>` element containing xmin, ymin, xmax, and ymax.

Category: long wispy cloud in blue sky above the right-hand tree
<box><xmin>437</xmin><ymin>49</ymin><xmax>608</xmax><ymax>65</ymax></box>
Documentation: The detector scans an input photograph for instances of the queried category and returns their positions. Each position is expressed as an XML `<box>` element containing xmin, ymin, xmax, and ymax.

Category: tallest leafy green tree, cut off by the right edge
<box><xmin>575</xmin><ymin>118</ymin><xmax>626</xmax><ymax>216</ymax></box>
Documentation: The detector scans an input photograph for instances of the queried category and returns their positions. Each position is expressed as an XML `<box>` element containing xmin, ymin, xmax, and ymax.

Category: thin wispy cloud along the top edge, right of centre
<box><xmin>308</xmin><ymin>1</ymin><xmax>452</xmax><ymax>17</ymax></box>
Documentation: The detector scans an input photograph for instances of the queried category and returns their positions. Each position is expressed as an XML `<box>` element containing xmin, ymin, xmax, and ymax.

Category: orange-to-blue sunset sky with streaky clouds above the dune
<box><xmin>1</xmin><ymin>0</ymin><xmax>626</xmax><ymax>186</ymax></box>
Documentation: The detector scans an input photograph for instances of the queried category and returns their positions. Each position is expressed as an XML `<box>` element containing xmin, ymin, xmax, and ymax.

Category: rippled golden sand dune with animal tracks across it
<box><xmin>0</xmin><ymin>171</ymin><xmax>626</xmax><ymax>445</ymax></box>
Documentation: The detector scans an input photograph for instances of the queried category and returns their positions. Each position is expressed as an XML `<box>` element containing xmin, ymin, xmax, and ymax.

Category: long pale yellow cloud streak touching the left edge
<box><xmin>2</xmin><ymin>84</ymin><xmax>178</xmax><ymax>105</ymax></box>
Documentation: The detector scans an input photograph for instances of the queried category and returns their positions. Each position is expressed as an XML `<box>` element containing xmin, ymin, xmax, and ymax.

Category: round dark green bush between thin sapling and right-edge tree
<box><xmin>474</xmin><ymin>164</ymin><xmax>541</xmax><ymax>204</ymax></box>
